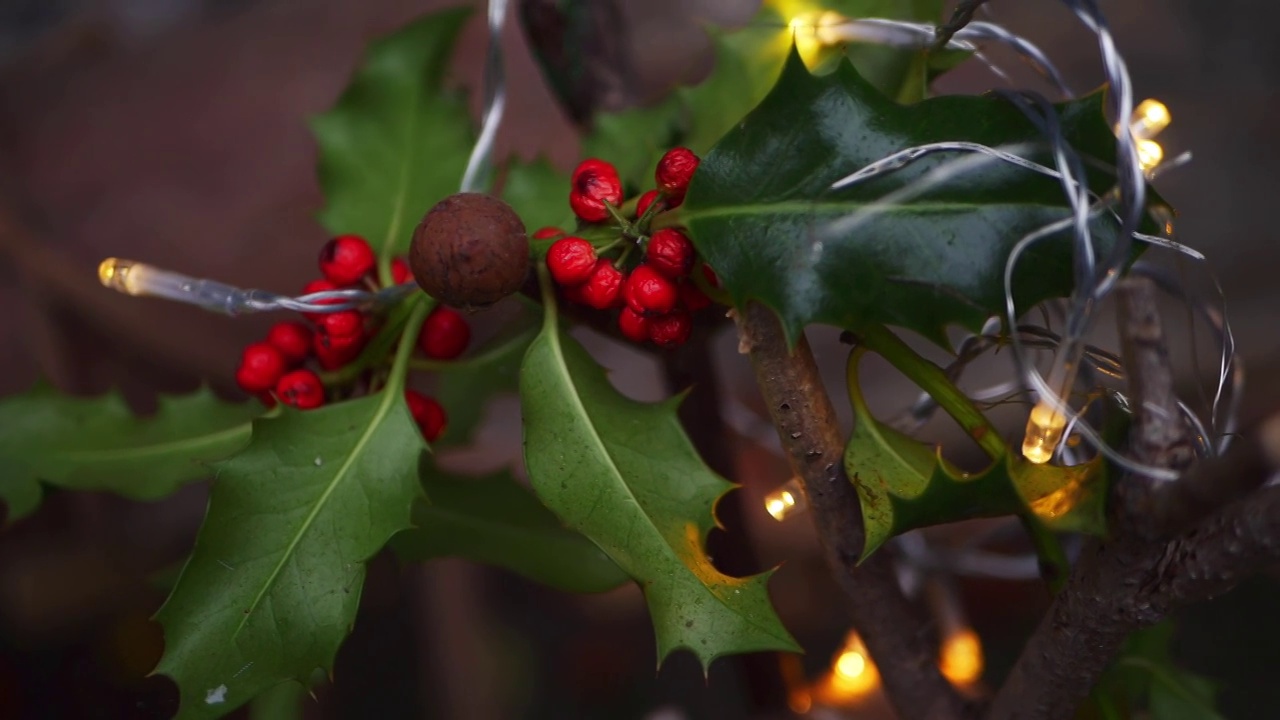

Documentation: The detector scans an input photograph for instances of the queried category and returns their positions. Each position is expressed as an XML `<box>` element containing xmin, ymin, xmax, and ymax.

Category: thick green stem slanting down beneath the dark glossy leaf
<box><xmin>854</xmin><ymin>324</ymin><xmax>1009</xmax><ymax>459</ymax></box>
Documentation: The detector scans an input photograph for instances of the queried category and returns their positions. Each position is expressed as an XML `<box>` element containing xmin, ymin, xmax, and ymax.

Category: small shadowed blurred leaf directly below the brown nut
<box><xmin>435</xmin><ymin>317</ymin><xmax>538</xmax><ymax>446</ymax></box>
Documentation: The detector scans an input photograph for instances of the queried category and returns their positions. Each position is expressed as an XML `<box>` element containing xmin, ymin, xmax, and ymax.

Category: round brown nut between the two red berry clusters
<box><xmin>408</xmin><ymin>192</ymin><xmax>529</xmax><ymax>307</ymax></box>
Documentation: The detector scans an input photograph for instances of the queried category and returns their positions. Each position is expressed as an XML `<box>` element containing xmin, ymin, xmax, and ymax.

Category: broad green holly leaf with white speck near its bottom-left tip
<box><xmin>156</xmin><ymin>383</ymin><xmax>425</xmax><ymax>717</ymax></box>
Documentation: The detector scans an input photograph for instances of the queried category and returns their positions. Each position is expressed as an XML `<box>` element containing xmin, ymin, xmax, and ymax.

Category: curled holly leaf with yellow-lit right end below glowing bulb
<box><xmin>845</xmin><ymin>350</ymin><xmax>1106</xmax><ymax>559</ymax></box>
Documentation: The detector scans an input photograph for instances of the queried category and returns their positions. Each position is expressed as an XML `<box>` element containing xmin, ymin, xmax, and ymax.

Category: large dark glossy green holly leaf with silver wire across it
<box><xmin>681</xmin><ymin>48</ymin><xmax>1153</xmax><ymax>347</ymax></box>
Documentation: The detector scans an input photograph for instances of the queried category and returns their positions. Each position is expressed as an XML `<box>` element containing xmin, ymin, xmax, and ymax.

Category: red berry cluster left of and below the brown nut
<box><xmin>236</xmin><ymin>234</ymin><xmax>471</xmax><ymax>441</ymax></box>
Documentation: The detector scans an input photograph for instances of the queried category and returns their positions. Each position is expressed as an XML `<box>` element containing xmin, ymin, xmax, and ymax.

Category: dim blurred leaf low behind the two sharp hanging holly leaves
<box><xmin>392</xmin><ymin>462</ymin><xmax>630</xmax><ymax>593</ymax></box>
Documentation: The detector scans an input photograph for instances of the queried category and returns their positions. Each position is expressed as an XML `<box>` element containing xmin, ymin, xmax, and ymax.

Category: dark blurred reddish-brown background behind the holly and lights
<box><xmin>0</xmin><ymin>0</ymin><xmax>1280</xmax><ymax>720</ymax></box>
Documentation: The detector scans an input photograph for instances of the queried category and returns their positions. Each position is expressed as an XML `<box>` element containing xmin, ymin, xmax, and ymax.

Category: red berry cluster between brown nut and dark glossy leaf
<box><xmin>534</xmin><ymin>147</ymin><xmax>716</xmax><ymax>347</ymax></box>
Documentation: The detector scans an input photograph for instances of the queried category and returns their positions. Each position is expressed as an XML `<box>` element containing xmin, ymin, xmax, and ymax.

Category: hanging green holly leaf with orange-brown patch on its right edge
<box><xmin>520</xmin><ymin>286</ymin><xmax>797</xmax><ymax>667</ymax></box>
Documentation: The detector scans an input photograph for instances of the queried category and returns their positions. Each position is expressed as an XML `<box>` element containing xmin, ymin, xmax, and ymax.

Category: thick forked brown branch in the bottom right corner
<box><xmin>988</xmin><ymin>281</ymin><xmax>1280</xmax><ymax>720</ymax></box>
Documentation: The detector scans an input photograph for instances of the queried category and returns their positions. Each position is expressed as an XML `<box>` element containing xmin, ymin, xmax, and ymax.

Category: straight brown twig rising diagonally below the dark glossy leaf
<box><xmin>736</xmin><ymin>305</ymin><xmax>965</xmax><ymax>720</ymax></box>
